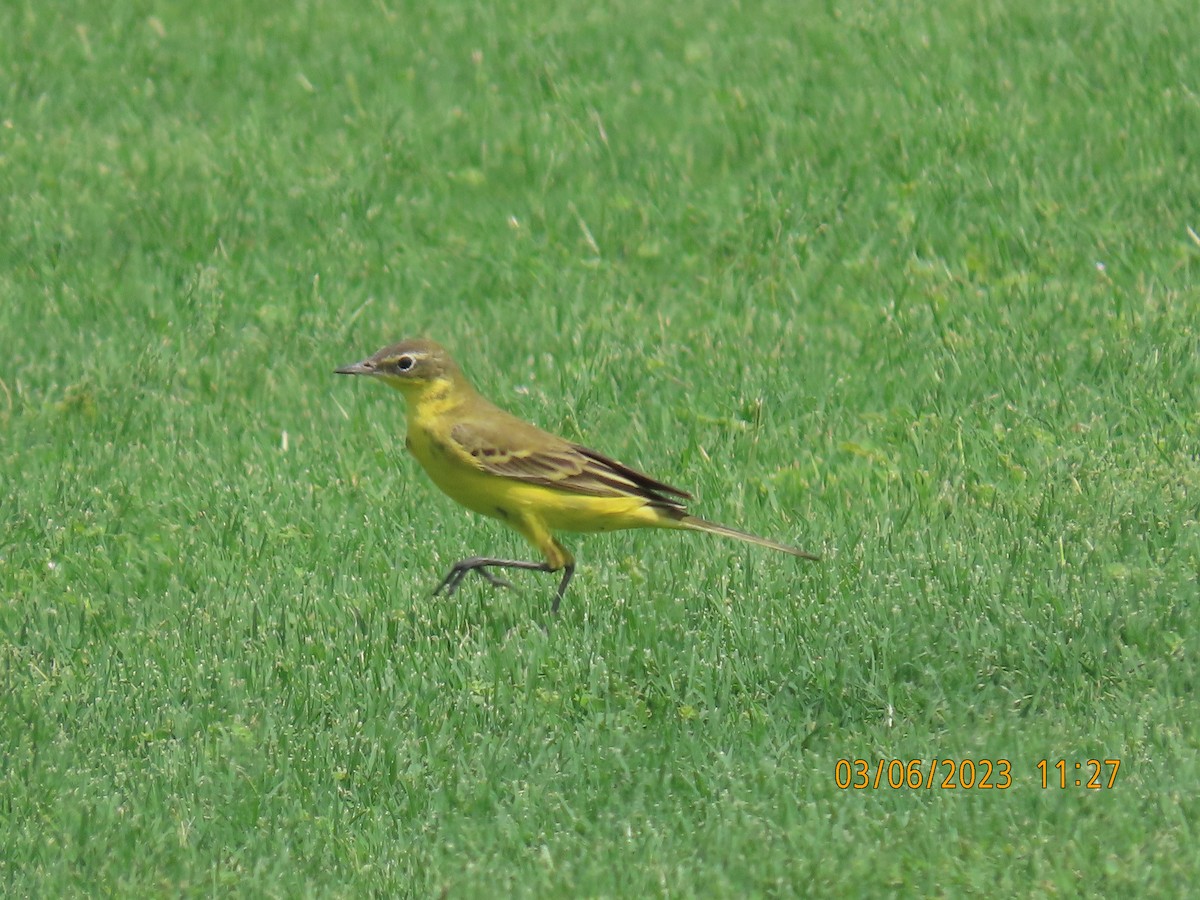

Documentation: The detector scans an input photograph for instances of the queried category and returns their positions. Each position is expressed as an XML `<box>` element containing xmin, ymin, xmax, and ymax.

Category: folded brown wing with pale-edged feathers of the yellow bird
<box><xmin>450</xmin><ymin>415</ymin><xmax>691</xmax><ymax>512</ymax></box>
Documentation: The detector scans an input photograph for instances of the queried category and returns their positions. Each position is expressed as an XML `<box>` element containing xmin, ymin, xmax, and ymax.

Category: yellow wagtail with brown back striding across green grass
<box><xmin>335</xmin><ymin>338</ymin><xmax>818</xmax><ymax>613</ymax></box>
